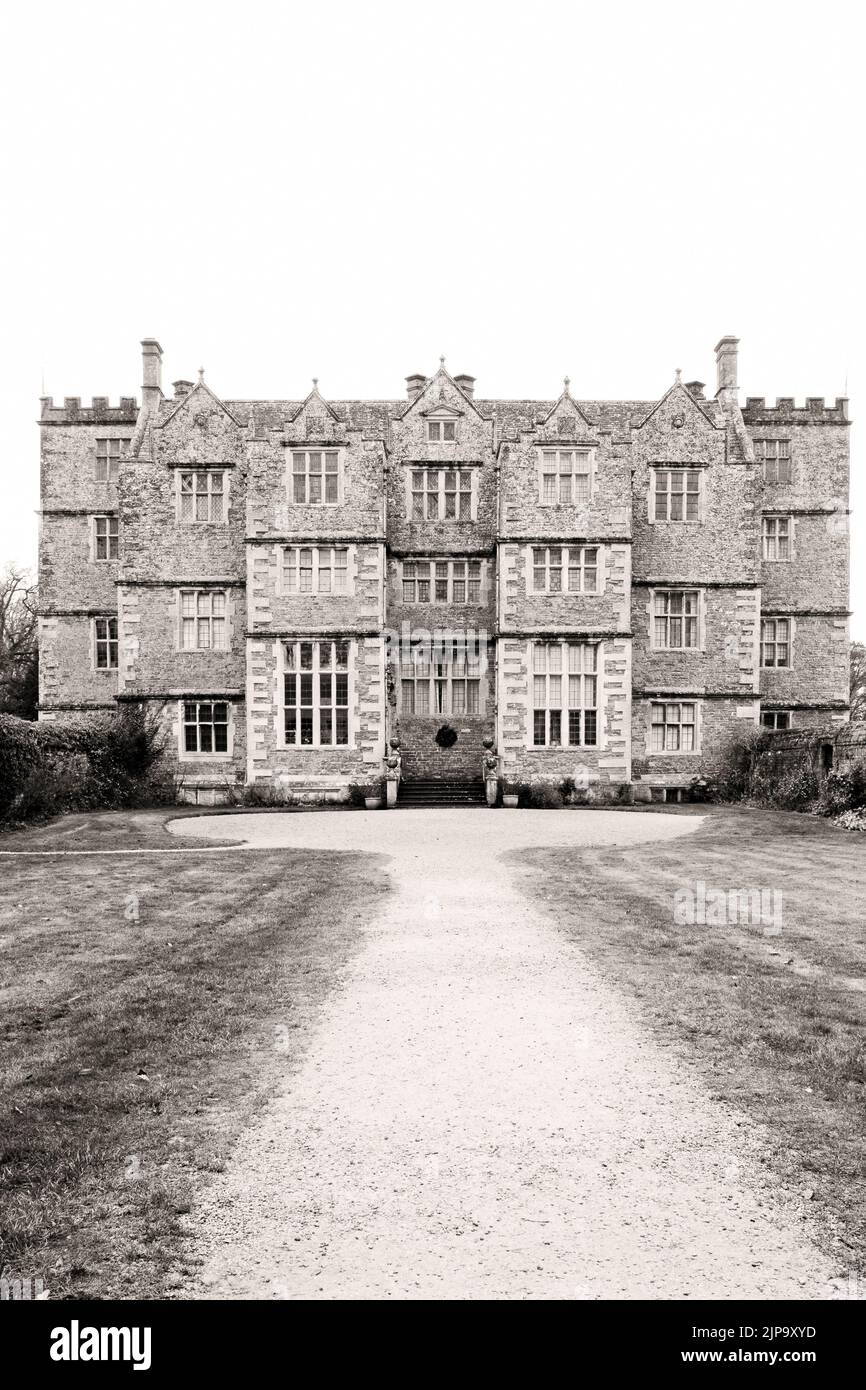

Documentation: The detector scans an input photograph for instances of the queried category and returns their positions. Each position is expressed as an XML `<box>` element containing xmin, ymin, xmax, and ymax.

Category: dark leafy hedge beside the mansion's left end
<box><xmin>0</xmin><ymin>706</ymin><xmax>170</xmax><ymax>821</ymax></box>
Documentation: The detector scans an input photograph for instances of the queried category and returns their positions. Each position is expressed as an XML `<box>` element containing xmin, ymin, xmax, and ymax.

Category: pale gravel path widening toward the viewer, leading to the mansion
<box><xmin>175</xmin><ymin>809</ymin><xmax>833</xmax><ymax>1298</ymax></box>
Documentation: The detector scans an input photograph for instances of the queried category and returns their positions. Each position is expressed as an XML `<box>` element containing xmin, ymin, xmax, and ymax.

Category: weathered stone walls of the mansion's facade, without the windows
<box><xmin>39</xmin><ymin>339</ymin><xmax>848</xmax><ymax>801</ymax></box>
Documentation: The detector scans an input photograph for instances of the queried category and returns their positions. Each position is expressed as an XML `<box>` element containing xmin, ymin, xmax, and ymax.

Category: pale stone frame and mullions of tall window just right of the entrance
<box><xmin>527</xmin><ymin>638</ymin><xmax>605</xmax><ymax>752</ymax></box>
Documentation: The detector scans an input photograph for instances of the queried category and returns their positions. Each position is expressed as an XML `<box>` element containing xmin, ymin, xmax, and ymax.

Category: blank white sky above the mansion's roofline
<box><xmin>0</xmin><ymin>0</ymin><xmax>866</xmax><ymax>638</ymax></box>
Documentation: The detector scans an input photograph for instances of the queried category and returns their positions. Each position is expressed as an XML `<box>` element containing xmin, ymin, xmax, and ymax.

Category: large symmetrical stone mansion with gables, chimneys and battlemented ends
<box><xmin>39</xmin><ymin>338</ymin><xmax>848</xmax><ymax>803</ymax></box>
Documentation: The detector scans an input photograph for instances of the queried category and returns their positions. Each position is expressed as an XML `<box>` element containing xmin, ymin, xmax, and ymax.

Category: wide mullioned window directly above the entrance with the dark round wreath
<box><xmin>399</xmin><ymin>634</ymin><xmax>488</xmax><ymax>719</ymax></box>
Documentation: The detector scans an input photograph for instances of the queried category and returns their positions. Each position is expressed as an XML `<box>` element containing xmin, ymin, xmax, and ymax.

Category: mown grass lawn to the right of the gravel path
<box><xmin>516</xmin><ymin>808</ymin><xmax>866</xmax><ymax>1276</ymax></box>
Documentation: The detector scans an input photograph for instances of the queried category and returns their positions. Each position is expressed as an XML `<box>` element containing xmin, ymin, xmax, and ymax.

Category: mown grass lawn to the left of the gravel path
<box><xmin>0</xmin><ymin>809</ymin><xmax>386</xmax><ymax>1298</ymax></box>
